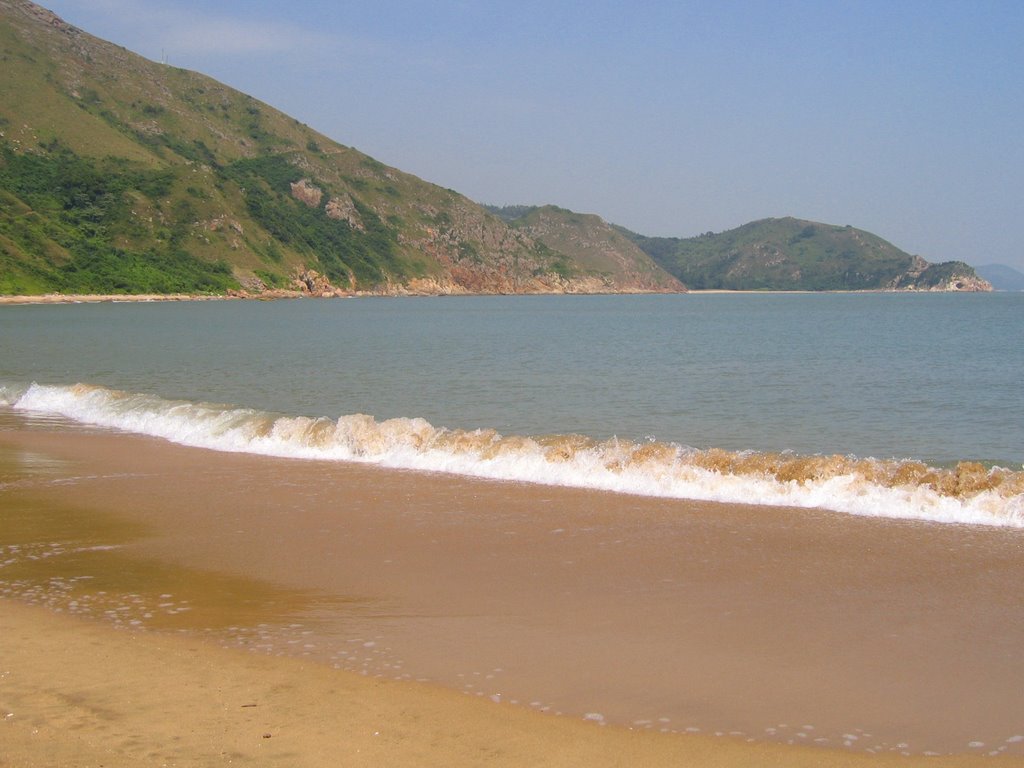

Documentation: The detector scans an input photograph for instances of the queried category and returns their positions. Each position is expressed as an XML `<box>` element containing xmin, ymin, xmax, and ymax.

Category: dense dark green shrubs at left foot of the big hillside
<box><xmin>0</xmin><ymin>141</ymin><xmax>238</xmax><ymax>294</ymax></box>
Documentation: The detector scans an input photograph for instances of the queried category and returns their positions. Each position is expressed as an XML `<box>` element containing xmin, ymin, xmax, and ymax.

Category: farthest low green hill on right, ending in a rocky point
<box><xmin>622</xmin><ymin>218</ymin><xmax>991</xmax><ymax>291</ymax></box>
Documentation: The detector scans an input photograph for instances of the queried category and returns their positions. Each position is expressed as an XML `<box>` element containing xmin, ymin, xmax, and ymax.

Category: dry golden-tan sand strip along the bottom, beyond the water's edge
<box><xmin>0</xmin><ymin>600</ymin><xmax>1007</xmax><ymax>768</ymax></box>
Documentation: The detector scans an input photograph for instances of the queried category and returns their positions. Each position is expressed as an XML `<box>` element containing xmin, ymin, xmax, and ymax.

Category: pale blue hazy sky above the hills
<box><xmin>42</xmin><ymin>0</ymin><xmax>1024</xmax><ymax>270</ymax></box>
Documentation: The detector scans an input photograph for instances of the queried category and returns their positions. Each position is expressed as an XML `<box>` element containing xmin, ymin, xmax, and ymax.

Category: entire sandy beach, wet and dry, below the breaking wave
<box><xmin>0</xmin><ymin>413</ymin><xmax>1024</xmax><ymax>766</ymax></box>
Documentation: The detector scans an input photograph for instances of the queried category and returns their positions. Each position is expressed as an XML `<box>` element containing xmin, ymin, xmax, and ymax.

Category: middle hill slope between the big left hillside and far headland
<box><xmin>487</xmin><ymin>206</ymin><xmax>686</xmax><ymax>291</ymax></box>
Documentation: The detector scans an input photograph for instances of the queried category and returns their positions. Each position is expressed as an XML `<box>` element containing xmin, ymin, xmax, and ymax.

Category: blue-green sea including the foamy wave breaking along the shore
<box><xmin>0</xmin><ymin>293</ymin><xmax>1024</xmax><ymax>527</ymax></box>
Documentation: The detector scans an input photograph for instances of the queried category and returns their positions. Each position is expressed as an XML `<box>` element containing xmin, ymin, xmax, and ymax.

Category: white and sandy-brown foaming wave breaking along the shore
<box><xmin>8</xmin><ymin>384</ymin><xmax>1024</xmax><ymax>527</ymax></box>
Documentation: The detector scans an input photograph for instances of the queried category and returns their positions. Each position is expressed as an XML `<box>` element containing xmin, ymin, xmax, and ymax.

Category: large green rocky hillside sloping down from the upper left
<box><xmin>0</xmin><ymin>0</ymin><xmax>675</xmax><ymax>294</ymax></box>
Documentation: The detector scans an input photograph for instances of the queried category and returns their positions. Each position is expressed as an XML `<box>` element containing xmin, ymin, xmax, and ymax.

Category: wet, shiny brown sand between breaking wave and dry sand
<box><xmin>0</xmin><ymin>414</ymin><xmax>1024</xmax><ymax>765</ymax></box>
